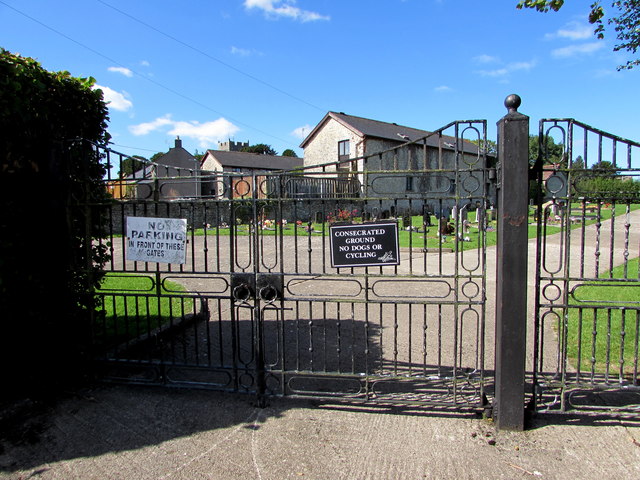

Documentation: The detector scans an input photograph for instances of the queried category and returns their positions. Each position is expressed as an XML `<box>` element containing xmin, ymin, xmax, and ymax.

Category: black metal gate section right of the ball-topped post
<box><xmin>533</xmin><ymin>120</ymin><xmax>640</xmax><ymax>411</ymax></box>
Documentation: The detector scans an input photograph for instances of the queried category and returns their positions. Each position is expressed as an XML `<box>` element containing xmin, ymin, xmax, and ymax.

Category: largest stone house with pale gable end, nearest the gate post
<box><xmin>300</xmin><ymin>112</ymin><xmax>495</xmax><ymax>216</ymax></box>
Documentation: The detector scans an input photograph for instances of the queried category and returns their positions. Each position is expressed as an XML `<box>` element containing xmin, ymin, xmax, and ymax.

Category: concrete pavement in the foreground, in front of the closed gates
<box><xmin>0</xmin><ymin>386</ymin><xmax>640</xmax><ymax>480</ymax></box>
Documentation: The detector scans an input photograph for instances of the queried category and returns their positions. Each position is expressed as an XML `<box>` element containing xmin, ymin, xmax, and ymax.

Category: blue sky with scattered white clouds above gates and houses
<box><xmin>0</xmin><ymin>0</ymin><xmax>640</xmax><ymax>157</ymax></box>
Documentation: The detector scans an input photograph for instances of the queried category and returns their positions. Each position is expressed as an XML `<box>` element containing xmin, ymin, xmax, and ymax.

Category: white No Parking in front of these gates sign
<box><xmin>126</xmin><ymin>217</ymin><xmax>187</xmax><ymax>263</ymax></box>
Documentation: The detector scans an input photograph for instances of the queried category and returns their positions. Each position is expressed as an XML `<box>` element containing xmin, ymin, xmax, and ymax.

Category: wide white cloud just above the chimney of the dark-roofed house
<box><xmin>129</xmin><ymin>114</ymin><xmax>240</xmax><ymax>148</ymax></box>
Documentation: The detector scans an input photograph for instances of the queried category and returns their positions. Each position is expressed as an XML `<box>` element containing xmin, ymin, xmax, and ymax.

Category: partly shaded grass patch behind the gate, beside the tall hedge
<box><xmin>94</xmin><ymin>273</ymin><xmax>194</xmax><ymax>345</ymax></box>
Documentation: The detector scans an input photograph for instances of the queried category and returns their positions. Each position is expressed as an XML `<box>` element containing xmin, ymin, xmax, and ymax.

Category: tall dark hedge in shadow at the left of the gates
<box><xmin>0</xmin><ymin>49</ymin><xmax>109</xmax><ymax>402</ymax></box>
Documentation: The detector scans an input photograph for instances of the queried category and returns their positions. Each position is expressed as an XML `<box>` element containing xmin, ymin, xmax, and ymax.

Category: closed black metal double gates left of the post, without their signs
<box><xmin>88</xmin><ymin>121</ymin><xmax>495</xmax><ymax>408</ymax></box>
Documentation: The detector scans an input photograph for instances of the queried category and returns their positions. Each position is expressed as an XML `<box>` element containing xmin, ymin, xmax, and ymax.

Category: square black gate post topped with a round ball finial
<box><xmin>494</xmin><ymin>95</ymin><xmax>529</xmax><ymax>430</ymax></box>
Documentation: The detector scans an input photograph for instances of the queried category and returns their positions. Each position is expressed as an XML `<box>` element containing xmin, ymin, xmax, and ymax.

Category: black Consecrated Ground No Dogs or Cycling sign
<box><xmin>329</xmin><ymin>222</ymin><xmax>400</xmax><ymax>268</ymax></box>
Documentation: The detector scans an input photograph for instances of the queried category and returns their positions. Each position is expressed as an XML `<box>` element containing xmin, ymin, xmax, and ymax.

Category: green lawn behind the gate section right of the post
<box><xmin>567</xmin><ymin>258</ymin><xmax>640</xmax><ymax>374</ymax></box>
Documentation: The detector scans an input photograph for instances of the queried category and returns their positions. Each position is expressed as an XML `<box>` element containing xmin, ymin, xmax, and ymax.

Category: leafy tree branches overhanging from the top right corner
<box><xmin>516</xmin><ymin>0</ymin><xmax>640</xmax><ymax>70</ymax></box>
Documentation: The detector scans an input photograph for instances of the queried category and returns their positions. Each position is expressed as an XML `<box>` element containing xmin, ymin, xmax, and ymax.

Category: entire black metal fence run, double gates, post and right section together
<box><xmin>70</xmin><ymin>96</ymin><xmax>640</xmax><ymax>429</ymax></box>
